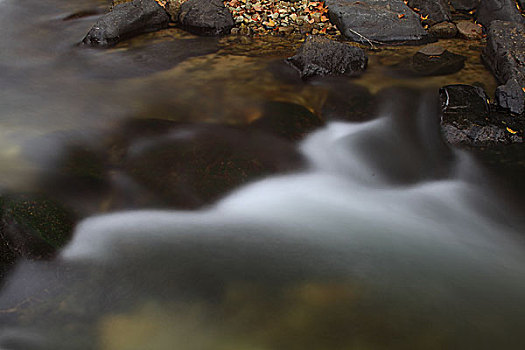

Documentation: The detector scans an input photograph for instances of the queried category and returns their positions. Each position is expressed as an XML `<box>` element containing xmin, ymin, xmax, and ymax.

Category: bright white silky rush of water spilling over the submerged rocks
<box><xmin>61</xmin><ymin>119</ymin><xmax>525</xmax><ymax>275</ymax></box>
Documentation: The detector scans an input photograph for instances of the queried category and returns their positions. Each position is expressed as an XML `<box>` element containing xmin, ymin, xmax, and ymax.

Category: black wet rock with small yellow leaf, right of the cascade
<box><xmin>440</xmin><ymin>85</ymin><xmax>523</xmax><ymax>146</ymax></box>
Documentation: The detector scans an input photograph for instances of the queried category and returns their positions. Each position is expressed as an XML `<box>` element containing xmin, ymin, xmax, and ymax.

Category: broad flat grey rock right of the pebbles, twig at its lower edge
<box><xmin>326</xmin><ymin>0</ymin><xmax>429</xmax><ymax>43</ymax></box>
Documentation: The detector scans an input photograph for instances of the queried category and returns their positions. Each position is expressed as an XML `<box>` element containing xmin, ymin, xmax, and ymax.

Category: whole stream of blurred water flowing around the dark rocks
<box><xmin>0</xmin><ymin>0</ymin><xmax>525</xmax><ymax>350</ymax></box>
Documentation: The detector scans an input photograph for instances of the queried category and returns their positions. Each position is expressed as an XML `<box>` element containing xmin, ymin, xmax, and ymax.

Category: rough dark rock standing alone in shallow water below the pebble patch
<box><xmin>287</xmin><ymin>36</ymin><xmax>368</xmax><ymax>79</ymax></box>
